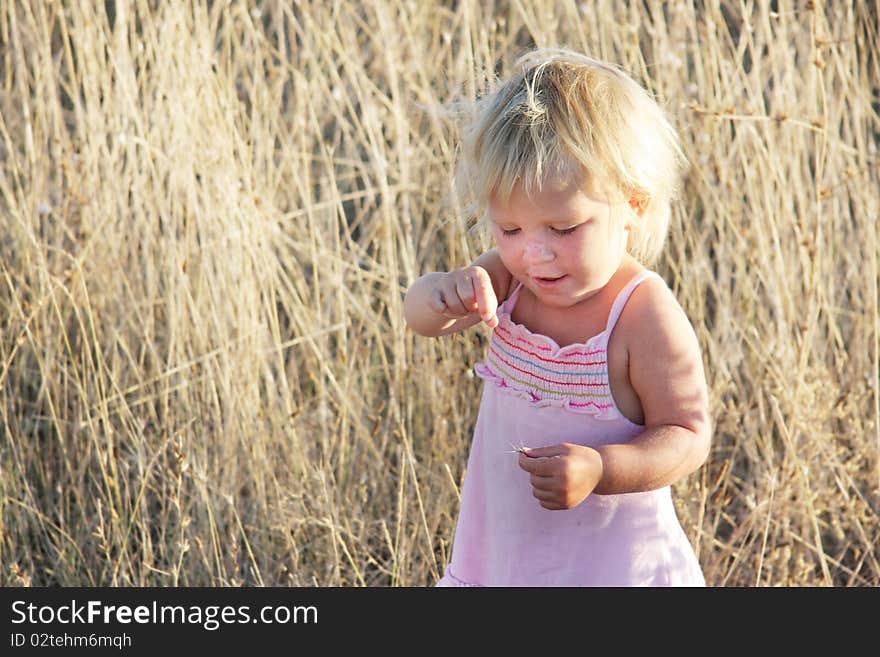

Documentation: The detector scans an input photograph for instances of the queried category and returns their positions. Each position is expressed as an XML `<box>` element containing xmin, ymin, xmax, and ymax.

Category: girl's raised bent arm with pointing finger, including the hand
<box><xmin>403</xmin><ymin>249</ymin><xmax>512</xmax><ymax>337</ymax></box>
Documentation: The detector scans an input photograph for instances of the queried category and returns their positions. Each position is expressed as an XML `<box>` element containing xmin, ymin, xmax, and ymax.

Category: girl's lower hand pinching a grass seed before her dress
<box><xmin>519</xmin><ymin>443</ymin><xmax>602</xmax><ymax>511</ymax></box>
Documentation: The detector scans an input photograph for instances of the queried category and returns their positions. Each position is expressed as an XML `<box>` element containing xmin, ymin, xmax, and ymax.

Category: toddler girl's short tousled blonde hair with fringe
<box><xmin>456</xmin><ymin>48</ymin><xmax>687</xmax><ymax>264</ymax></box>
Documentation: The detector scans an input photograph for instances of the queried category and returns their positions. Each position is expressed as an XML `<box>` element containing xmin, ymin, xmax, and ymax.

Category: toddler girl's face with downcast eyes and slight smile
<box><xmin>488</xmin><ymin>173</ymin><xmax>629</xmax><ymax>308</ymax></box>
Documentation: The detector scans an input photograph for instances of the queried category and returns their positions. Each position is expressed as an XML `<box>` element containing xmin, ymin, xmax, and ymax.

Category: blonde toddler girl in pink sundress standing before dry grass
<box><xmin>405</xmin><ymin>49</ymin><xmax>711</xmax><ymax>586</ymax></box>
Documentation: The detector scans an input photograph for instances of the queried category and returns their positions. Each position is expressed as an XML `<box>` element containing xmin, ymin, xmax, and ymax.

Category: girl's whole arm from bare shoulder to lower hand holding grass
<box><xmin>519</xmin><ymin>281</ymin><xmax>711</xmax><ymax>509</ymax></box>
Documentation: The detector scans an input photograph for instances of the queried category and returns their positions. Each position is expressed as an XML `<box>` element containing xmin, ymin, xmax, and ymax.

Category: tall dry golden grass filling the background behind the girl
<box><xmin>0</xmin><ymin>0</ymin><xmax>880</xmax><ymax>586</ymax></box>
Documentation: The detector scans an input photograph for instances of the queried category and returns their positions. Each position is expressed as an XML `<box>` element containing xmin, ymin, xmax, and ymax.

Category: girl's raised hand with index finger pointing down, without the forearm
<box><xmin>428</xmin><ymin>265</ymin><xmax>498</xmax><ymax>328</ymax></box>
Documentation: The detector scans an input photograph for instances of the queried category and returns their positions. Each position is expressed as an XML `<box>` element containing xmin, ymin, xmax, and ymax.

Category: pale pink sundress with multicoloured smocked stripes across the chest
<box><xmin>437</xmin><ymin>271</ymin><xmax>705</xmax><ymax>586</ymax></box>
